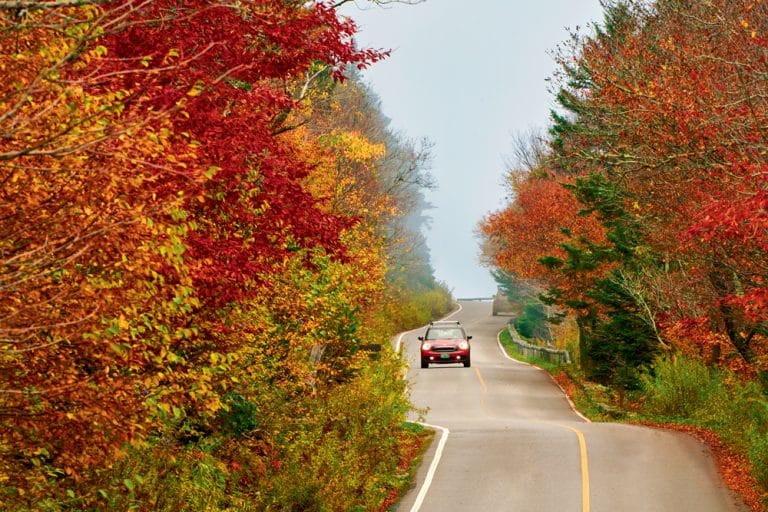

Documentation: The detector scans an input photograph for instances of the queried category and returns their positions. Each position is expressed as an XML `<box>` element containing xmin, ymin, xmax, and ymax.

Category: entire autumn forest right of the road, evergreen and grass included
<box><xmin>480</xmin><ymin>0</ymin><xmax>768</xmax><ymax>500</ymax></box>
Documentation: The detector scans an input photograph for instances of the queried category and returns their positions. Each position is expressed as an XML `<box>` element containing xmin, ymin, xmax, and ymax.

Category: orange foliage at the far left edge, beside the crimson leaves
<box><xmin>0</xmin><ymin>6</ymin><xmax>202</xmax><ymax>488</ymax></box>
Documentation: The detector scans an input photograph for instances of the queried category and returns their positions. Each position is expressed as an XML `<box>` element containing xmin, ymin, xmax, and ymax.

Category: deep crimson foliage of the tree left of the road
<box><xmin>101</xmin><ymin>0</ymin><xmax>385</xmax><ymax>306</ymax></box>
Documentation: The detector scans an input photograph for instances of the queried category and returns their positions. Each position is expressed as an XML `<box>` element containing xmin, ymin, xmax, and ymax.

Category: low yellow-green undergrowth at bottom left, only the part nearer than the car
<box><xmin>25</xmin><ymin>351</ymin><xmax>414</xmax><ymax>512</ymax></box>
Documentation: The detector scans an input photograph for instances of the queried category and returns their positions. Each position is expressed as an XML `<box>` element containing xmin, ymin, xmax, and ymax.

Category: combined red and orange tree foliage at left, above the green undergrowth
<box><xmin>0</xmin><ymin>0</ymin><xmax>383</xmax><ymax>489</ymax></box>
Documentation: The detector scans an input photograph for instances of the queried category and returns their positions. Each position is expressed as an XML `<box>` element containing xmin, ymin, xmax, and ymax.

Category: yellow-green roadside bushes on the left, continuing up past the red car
<box><xmin>16</xmin><ymin>276</ymin><xmax>444</xmax><ymax>512</ymax></box>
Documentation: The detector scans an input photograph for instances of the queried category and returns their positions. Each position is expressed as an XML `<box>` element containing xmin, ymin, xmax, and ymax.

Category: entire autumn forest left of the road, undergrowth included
<box><xmin>0</xmin><ymin>0</ymin><xmax>452</xmax><ymax>511</ymax></box>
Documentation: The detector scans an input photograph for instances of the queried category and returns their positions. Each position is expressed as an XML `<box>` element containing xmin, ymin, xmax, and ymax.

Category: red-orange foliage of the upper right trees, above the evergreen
<box><xmin>540</xmin><ymin>0</ymin><xmax>768</xmax><ymax>363</ymax></box>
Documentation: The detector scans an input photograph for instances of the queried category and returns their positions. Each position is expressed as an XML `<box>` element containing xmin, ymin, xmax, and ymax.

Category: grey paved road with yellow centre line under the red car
<box><xmin>398</xmin><ymin>302</ymin><xmax>747</xmax><ymax>512</ymax></box>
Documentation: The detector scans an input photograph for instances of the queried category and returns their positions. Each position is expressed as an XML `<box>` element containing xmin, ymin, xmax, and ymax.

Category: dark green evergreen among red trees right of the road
<box><xmin>541</xmin><ymin>173</ymin><xmax>658</xmax><ymax>389</ymax></box>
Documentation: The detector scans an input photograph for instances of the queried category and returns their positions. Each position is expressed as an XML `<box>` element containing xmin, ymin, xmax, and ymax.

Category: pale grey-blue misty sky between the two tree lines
<box><xmin>341</xmin><ymin>0</ymin><xmax>602</xmax><ymax>298</ymax></box>
